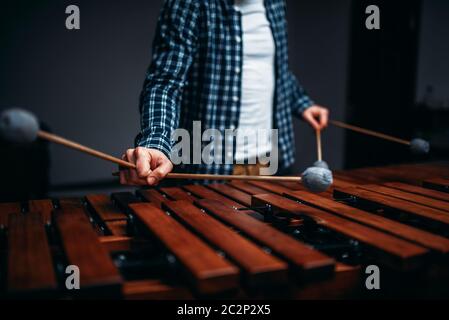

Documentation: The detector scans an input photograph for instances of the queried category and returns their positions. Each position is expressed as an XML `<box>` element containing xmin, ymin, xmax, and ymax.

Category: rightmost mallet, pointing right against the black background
<box><xmin>329</xmin><ymin>120</ymin><xmax>430</xmax><ymax>154</ymax></box>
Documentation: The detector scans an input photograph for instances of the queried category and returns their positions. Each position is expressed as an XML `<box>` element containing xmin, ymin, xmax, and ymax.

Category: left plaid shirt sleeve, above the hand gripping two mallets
<box><xmin>135</xmin><ymin>0</ymin><xmax>200</xmax><ymax>157</ymax></box>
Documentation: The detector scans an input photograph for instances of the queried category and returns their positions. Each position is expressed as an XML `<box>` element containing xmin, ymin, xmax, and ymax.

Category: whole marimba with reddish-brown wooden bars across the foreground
<box><xmin>0</xmin><ymin>163</ymin><xmax>449</xmax><ymax>299</ymax></box>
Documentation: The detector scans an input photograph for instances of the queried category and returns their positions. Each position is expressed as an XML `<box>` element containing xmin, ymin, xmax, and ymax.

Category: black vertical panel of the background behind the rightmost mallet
<box><xmin>346</xmin><ymin>0</ymin><xmax>421</xmax><ymax>167</ymax></box>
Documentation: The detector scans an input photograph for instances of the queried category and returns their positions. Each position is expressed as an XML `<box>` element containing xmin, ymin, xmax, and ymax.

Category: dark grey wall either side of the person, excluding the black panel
<box><xmin>0</xmin><ymin>0</ymin><xmax>350</xmax><ymax>191</ymax></box>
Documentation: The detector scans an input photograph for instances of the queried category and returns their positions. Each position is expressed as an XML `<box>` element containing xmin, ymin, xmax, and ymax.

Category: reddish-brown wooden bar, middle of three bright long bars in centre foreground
<box><xmin>164</xmin><ymin>201</ymin><xmax>288</xmax><ymax>286</ymax></box>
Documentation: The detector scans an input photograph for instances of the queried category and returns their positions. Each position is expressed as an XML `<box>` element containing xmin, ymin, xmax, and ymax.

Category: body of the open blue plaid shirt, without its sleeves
<box><xmin>179</xmin><ymin>0</ymin><xmax>294</xmax><ymax>173</ymax></box>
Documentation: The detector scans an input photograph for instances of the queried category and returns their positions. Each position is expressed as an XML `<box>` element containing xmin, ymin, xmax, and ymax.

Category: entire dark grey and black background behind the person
<box><xmin>0</xmin><ymin>0</ymin><xmax>449</xmax><ymax>200</ymax></box>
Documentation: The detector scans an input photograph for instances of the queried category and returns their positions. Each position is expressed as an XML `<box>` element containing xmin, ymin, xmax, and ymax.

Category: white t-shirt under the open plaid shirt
<box><xmin>235</xmin><ymin>0</ymin><xmax>276</xmax><ymax>161</ymax></box>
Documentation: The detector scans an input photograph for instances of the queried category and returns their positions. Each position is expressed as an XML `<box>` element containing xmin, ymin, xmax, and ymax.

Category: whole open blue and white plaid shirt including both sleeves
<box><xmin>136</xmin><ymin>0</ymin><xmax>313</xmax><ymax>174</ymax></box>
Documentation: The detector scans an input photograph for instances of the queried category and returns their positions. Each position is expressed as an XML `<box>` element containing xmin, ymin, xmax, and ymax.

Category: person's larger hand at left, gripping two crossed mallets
<box><xmin>120</xmin><ymin>147</ymin><xmax>173</xmax><ymax>186</ymax></box>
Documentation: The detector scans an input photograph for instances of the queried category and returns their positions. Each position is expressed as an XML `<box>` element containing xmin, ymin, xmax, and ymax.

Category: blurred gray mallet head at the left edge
<box><xmin>0</xmin><ymin>108</ymin><xmax>39</xmax><ymax>143</ymax></box>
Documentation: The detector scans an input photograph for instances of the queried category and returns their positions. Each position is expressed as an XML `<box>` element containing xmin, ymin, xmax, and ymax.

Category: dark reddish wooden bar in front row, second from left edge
<box><xmin>54</xmin><ymin>205</ymin><xmax>121</xmax><ymax>295</ymax></box>
